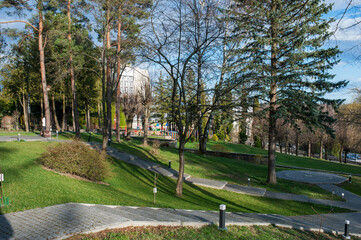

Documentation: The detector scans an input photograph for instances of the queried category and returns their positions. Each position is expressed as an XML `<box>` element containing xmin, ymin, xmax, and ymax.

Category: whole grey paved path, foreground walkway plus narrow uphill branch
<box><xmin>0</xmin><ymin>138</ymin><xmax>361</xmax><ymax>240</ymax></box>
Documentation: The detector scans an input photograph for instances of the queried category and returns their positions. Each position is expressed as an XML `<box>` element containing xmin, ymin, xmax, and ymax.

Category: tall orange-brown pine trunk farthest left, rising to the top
<box><xmin>38</xmin><ymin>4</ymin><xmax>51</xmax><ymax>137</ymax></box>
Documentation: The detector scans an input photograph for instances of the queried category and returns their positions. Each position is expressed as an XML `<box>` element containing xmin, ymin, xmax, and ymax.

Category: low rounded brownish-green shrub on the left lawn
<box><xmin>40</xmin><ymin>141</ymin><xmax>110</xmax><ymax>181</ymax></box>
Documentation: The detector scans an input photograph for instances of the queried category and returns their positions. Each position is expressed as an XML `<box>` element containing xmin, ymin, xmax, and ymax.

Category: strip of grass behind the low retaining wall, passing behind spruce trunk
<box><xmin>186</xmin><ymin>141</ymin><xmax>361</xmax><ymax>174</ymax></box>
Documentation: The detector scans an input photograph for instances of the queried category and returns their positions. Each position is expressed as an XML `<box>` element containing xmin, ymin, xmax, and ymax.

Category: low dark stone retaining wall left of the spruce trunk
<box><xmin>185</xmin><ymin>149</ymin><xmax>268</xmax><ymax>165</ymax></box>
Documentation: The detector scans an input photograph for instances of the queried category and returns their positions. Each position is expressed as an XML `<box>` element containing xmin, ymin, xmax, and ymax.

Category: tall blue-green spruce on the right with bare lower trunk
<box><xmin>229</xmin><ymin>0</ymin><xmax>347</xmax><ymax>184</ymax></box>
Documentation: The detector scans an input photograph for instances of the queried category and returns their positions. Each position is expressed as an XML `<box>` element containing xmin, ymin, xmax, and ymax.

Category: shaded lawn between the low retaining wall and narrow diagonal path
<box><xmin>62</xmin><ymin>134</ymin><xmax>341</xmax><ymax>200</ymax></box>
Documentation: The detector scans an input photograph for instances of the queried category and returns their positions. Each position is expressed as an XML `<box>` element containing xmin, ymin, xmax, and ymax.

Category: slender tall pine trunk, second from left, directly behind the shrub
<box><xmin>67</xmin><ymin>0</ymin><xmax>80</xmax><ymax>138</ymax></box>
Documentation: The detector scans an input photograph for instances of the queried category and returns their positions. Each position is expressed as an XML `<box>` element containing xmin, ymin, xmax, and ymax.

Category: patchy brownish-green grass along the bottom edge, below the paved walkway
<box><xmin>68</xmin><ymin>226</ymin><xmax>354</xmax><ymax>240</ymax></box>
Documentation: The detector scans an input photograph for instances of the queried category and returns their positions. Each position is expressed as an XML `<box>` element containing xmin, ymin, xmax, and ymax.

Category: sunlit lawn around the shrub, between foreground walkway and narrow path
<box><xmin>0</xmin><ymin>142</ymin><xmax>348</xmax><ymax>215</ymax></box>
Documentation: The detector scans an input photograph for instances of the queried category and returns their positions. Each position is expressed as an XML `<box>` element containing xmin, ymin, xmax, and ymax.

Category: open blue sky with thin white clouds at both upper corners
<box><xmin>0</xmin><ymin>0</ymin><xmax>361</xmax><ymax>103</ymax></box>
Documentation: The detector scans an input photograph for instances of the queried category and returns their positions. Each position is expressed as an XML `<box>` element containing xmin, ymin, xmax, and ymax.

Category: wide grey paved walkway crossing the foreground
<box><xmin>0</xmin><ymin>203</ymin><xmax>361</xmax><ymax>240</ymax></box>
